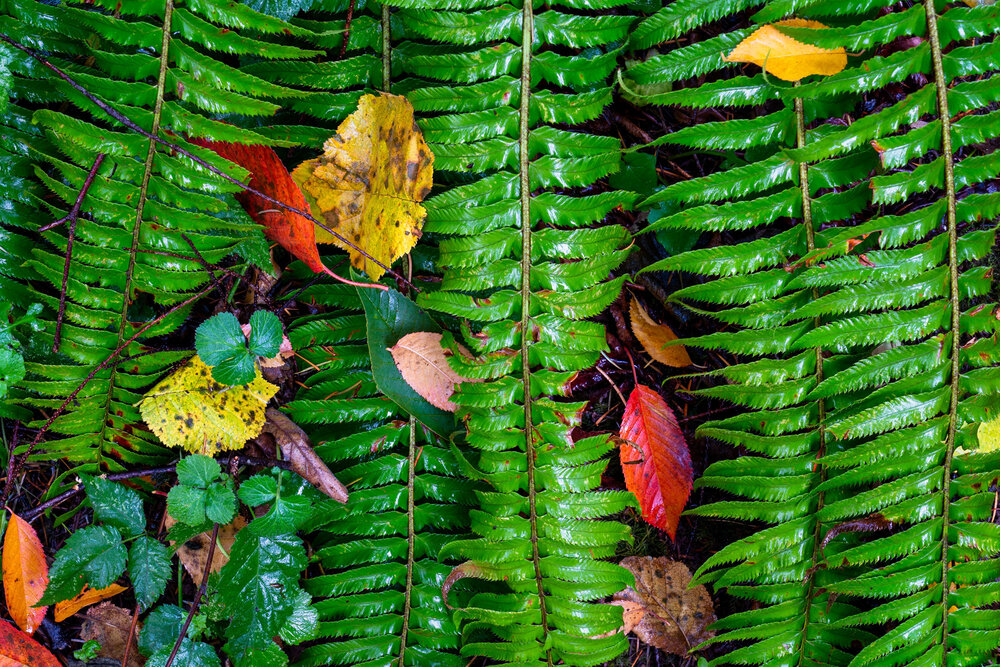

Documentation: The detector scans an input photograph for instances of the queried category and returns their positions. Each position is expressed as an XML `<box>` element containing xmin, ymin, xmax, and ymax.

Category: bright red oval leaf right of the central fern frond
<box><xmin>621</xmin><ymin>384</ymin><xmax>694</xmax><ymax>539</ymax></box>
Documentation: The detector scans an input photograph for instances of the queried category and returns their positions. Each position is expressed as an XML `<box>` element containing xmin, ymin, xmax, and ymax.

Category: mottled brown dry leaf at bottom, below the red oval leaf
<box><xmin>614</xmin><ymin>556</ymin><xmax>715</xmax><ymax>656</ymax></box>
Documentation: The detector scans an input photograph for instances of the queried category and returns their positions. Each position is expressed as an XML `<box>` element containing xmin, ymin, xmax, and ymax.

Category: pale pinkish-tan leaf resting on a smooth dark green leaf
<box><xmin>389</xmin><ymin>331</ymin><xmax>482</xmax><ymax>412</ymax></box>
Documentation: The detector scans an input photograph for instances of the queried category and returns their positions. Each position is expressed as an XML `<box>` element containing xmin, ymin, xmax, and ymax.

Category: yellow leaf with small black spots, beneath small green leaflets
<box><xmin>139</xmin><ymin>355</ymin><xmax>278</xmax><ymax>456</ymax></box>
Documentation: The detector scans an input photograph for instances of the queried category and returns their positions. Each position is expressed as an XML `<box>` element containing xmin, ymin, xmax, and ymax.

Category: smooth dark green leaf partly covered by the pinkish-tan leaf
<box><xmin>358</xmin><ymin>290</ymin><xmax>455</xmax><ymax>435</ymax></box>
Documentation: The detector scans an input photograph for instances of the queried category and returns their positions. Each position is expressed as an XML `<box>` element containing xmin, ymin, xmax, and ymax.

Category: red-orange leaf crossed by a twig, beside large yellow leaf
<box><xmin>188</xmin><ymin>138</ymin><xmax>330</xmax><ymax>273</ymax></box>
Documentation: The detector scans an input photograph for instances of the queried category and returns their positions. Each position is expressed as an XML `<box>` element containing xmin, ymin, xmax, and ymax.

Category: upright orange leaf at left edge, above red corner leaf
<box><xmin>3</xmin><ymin>514</ymin><xmax>49</xmax><ymax>635</ymax></box>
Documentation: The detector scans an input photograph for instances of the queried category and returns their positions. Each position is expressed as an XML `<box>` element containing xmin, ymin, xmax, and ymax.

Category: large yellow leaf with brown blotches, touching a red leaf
<box><xmin>292</xmin><ymin>94</ymin><xmax>434</xmax><ymax>280</ymax></box>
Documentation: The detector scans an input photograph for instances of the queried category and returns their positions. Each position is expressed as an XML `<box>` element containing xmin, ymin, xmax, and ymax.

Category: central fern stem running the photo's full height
<box><xmin>518</xmin><ymin>0</ymin><xmax>552</xmax><ymax>665</ymax></box>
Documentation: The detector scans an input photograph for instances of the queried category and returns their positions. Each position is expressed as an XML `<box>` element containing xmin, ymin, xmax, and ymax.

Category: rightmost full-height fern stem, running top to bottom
<box><xmin>924</xmin><ymin>0</ymin><xmax>962</xmax><ymax>664</ymax></box>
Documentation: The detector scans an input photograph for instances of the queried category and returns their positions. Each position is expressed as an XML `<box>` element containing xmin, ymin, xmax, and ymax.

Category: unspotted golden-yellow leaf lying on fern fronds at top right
<box><xmin>722</xmin><ymin>19</ymin><xmax>847</xmax><ymax>81</ymax></box>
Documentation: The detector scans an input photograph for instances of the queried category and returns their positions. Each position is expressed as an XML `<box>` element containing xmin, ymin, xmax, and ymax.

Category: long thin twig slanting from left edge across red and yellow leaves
<box><xmin>0</xmin><ymin>32</ymin><xmax>420</xmax><ymax>292</ymax></box>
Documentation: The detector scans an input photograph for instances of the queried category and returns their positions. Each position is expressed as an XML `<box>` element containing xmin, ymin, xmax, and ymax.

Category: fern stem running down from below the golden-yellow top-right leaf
<box><xmin>795</xmin><ymin>95</ymin><xmax>826</xmax><ymax>667</ymax></box>
